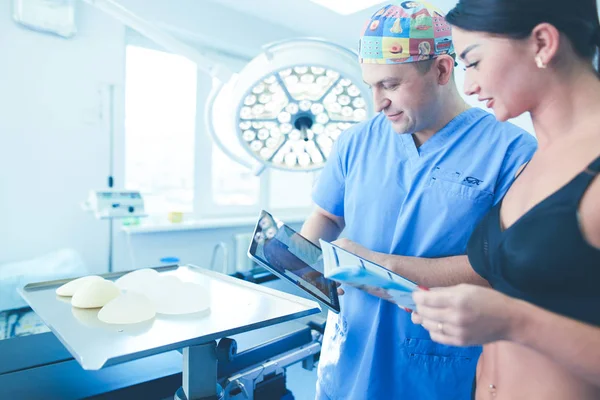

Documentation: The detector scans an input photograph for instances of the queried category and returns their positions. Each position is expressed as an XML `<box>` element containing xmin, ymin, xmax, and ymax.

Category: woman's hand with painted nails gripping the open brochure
<box><xmin>412</xmin><ymin>284</ymin><xmax>520</xmax><ymax>346</ymax></box>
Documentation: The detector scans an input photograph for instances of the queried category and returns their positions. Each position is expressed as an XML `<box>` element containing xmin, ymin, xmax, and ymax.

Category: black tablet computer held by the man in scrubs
<box><xmin>248</xmin><ymin>210</ymin><xmax>340</xmax><ymax>313</ymax></box>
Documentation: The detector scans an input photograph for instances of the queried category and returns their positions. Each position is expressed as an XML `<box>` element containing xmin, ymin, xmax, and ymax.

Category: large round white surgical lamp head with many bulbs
<box><xmin>206</xmin><ymin>38</ymin><xmax>372</xmax><ymax>174</ymax></box>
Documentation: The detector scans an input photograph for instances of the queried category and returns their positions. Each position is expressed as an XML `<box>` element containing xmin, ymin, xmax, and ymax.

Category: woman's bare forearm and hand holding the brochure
<box><xmin>412</xmin><ymin>285</ymin><xmax>600</xmax><ymax>386</ymax></box>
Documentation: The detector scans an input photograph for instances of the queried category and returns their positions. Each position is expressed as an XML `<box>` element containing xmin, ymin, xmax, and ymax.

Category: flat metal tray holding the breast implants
<box><xmin>19</xmin><ymin>265</ymin><xmax>321</xmax><ymax>370</ymax></box>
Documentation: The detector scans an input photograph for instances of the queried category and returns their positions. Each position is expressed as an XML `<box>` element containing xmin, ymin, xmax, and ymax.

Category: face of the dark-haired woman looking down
<box><xmin>452</xmin><ymin>27</ymin><xmax>543</xmax><ymax>121</ymax></box>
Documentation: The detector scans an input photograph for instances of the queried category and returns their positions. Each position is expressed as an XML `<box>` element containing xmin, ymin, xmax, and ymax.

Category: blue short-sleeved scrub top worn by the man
<box><xmin>313</xmin><ymin>108</ymin><xmax>537</xmax><ymax>400</ymax></box>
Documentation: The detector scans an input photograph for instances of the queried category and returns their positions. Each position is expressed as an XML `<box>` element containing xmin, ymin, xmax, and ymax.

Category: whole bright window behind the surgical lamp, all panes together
<box><xmin>125</xmin><ymin>45</ymin><xmax>316</xmax><ymax>222</ymax></box>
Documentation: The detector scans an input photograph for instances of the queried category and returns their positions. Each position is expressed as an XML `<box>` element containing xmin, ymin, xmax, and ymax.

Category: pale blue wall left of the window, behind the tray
<box><xmin>0</xmin><ymin>1</ymin><xmax>124</xmax><ymax>270</ymax></box>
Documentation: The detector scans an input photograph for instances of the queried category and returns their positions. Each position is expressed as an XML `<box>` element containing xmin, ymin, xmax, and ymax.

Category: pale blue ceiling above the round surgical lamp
<box><xmin>111</xmin><ymin>0</ymin><xmax>464</xmax><ymax>59</ymax></box>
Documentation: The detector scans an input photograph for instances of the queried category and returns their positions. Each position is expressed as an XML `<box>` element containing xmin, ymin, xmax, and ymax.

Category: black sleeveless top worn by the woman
<box><xmin>467</xmin><ymin>157</ymin><xmax>600</xmax><ymax>326</ymax></box>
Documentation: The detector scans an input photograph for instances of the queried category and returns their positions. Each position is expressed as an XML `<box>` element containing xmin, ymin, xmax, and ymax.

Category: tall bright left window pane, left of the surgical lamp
<box><xmin>125</xmin><ymin>46</ymin><xmax>197</xmax><ymax>214</ymax></box>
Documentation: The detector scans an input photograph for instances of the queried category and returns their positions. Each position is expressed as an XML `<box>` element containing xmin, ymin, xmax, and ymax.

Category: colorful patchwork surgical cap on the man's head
<box><xmin>358</xmin><ymin>1</ymin><xmax>454</xmax><ymax>64</ymax></box>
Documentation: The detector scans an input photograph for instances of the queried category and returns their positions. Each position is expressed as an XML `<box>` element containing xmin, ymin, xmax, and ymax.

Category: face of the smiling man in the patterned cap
<box><xmin>361</xmin><ymin>63</ymin><xmax>439</xmax><ymax>134</ymax></box>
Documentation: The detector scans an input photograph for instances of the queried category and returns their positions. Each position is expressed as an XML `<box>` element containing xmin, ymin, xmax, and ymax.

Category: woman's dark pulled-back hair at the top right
<box><xmin>446</xmin><ymin>0</ymin><xmax>600</xmax><ymax>68</ymax></box>
